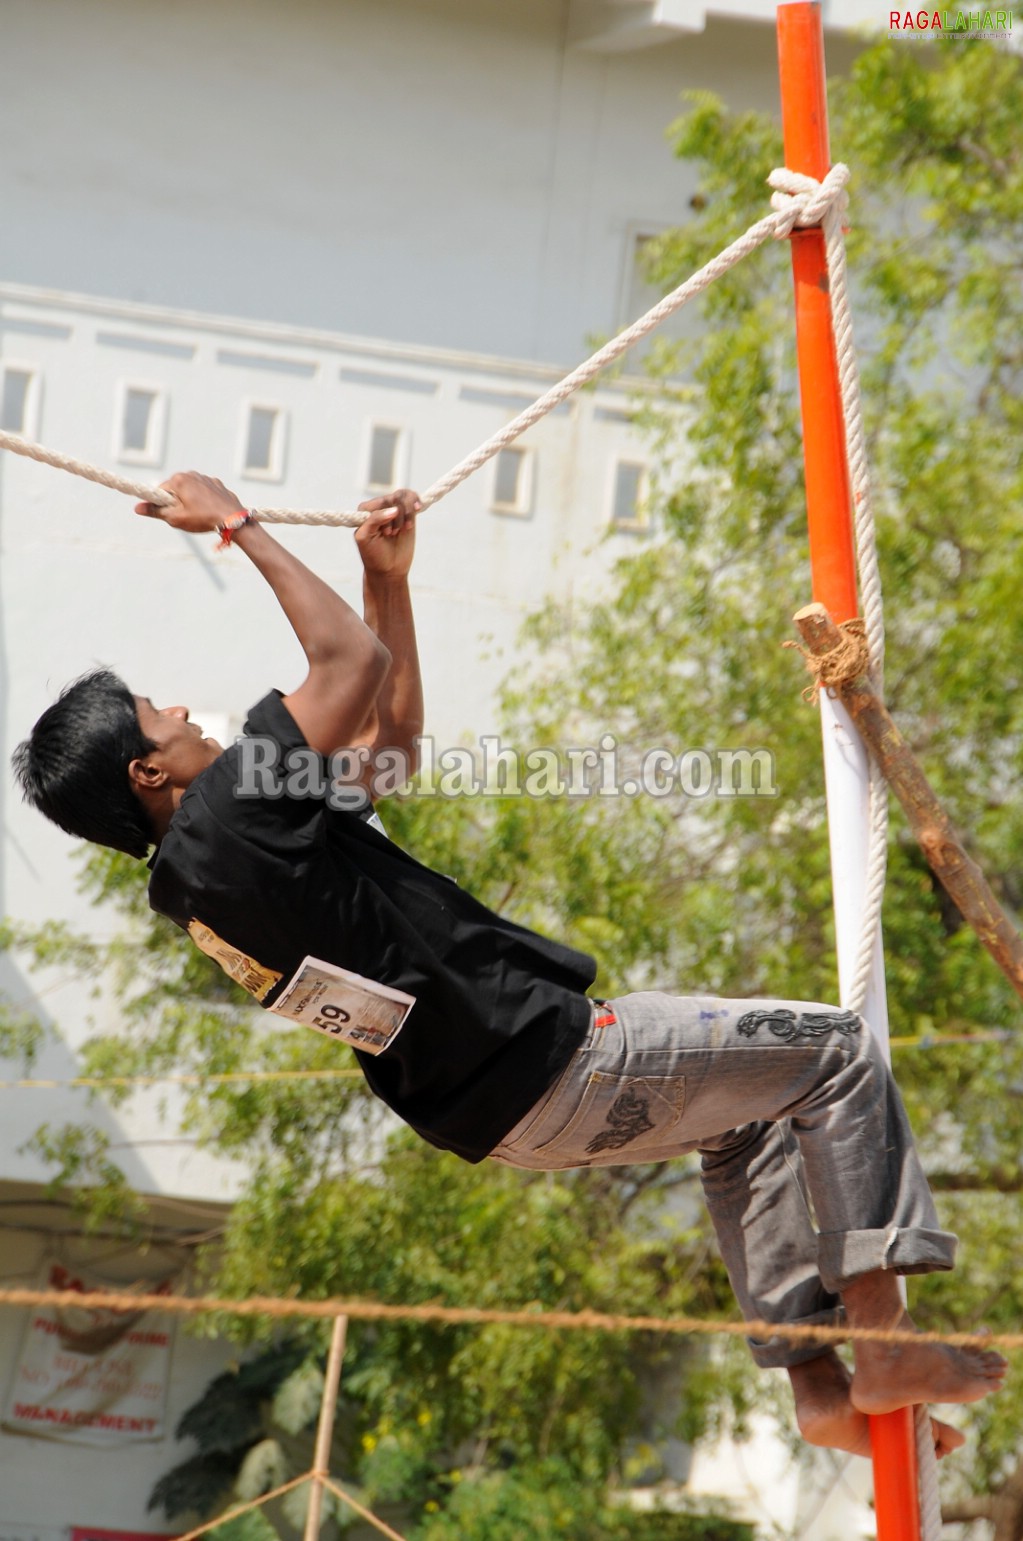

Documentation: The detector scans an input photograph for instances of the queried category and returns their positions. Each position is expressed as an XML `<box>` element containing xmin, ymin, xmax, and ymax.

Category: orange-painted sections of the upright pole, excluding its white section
<box><xmin>778</xmin><ymin>0</ymin><xmax>920</xmax><ymax>1541</ymax></box>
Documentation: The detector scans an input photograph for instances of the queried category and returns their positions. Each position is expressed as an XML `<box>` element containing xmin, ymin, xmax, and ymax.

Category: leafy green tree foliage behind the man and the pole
<box><xmin>5</xmin><ymin>42</ymin><xmax>1023</xmax><ymax>1541</ymax></box>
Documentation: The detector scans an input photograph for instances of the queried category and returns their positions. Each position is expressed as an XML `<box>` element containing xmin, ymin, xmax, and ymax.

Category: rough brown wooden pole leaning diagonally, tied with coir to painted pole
<box><xmin>793</xmin><ymin>604</ymin><xmax>1023</xmax><ymax>997</ymax></box>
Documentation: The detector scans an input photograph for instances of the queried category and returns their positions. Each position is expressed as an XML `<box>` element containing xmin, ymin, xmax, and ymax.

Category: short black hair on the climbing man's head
<box><xmin>11</xmin><ymin>669</ymin><xmax>156</xmax><ymax>857</ymax></box>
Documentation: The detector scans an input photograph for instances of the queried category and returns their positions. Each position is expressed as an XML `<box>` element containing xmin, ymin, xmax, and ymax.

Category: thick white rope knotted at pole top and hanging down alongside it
<box><xmin>767</xmin><ymin>170</ymin><xmax>887</xmax><ymax>1011</ymax></box>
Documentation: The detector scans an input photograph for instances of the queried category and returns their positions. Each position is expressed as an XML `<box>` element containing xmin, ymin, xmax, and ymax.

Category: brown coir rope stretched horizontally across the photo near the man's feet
<box><xmin>0</xmin><ymin>1290</ymin><xmax>1023</xmax><ymax>1349</ymax></box>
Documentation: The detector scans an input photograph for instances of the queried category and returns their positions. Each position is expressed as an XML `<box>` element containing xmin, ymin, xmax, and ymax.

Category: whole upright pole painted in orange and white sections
<box><xmin>778</xmin><ymin>0</ymin><xmax>920</xmax><ymax>1541</ymax></box>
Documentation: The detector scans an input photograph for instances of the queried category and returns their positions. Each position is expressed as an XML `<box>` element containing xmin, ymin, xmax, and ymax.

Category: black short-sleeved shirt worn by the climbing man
<box><xmin>149</xmin><ymin>690</ymin><xmax>596</xmax><ymax>1162</ymax></box>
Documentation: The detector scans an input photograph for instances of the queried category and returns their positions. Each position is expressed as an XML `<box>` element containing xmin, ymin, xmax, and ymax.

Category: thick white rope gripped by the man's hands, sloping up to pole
<box><xmin>0</xmin><ymin>165</ymin><xmax>849</xmax><ymax>527</ymax></box>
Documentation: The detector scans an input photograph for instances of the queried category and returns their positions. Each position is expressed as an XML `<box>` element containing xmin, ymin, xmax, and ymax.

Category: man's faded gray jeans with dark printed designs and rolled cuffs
<box><xmin>491</xmin><ymin>991</ymin><xmax>955</xmax><ymax>1367</ymax></box>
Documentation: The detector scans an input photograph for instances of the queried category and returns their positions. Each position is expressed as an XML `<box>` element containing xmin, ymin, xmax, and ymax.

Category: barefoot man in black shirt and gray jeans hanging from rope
<box><xmin>14</xmin><ymin>473</ymin><xmax>1006</xmax><ymax>1455</ymax></box>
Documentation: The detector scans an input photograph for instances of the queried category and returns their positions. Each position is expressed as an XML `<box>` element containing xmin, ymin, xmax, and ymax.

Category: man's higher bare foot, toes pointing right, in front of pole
<box><xmin>843</xmin><ymin>1273</ymin><xmax>1008</xmax><ymax>1413</ymax></box>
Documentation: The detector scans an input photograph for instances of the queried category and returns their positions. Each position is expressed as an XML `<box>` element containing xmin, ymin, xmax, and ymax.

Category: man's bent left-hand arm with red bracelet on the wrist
<box><xmin>136</xmin><ymin>472</ymin><xmax>391</xmax><ymax>755</ymax></box>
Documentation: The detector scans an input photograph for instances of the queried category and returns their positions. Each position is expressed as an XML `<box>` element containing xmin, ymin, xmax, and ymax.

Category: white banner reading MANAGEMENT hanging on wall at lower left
<box><xmin>3</xmin><ymin>1264</ymin><xmax>173</xmax><ymax>1445</ymax></box>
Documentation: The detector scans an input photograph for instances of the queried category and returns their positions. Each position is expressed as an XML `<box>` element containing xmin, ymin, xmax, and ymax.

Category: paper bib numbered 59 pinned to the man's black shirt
<box><xmin>270</xmin><ymin>957</ymin><xmax>416</xmax><ymax>1054</ymax></box>
